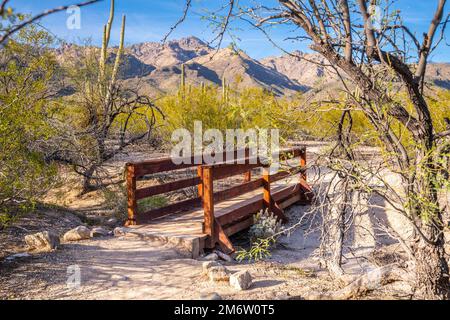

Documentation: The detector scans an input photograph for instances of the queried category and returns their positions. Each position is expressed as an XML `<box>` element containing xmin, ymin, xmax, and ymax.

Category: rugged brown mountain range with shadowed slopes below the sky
<box><xmin>58</xmin><ymin>37</ymin><xmax>450</xmax><ymax>95</ymax></box>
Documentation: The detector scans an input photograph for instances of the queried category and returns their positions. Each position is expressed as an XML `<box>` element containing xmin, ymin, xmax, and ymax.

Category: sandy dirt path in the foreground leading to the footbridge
<box><xmin>0</xmin><ymin>230</ymin><xmax>338</xmax><ymax>299</ymax></box>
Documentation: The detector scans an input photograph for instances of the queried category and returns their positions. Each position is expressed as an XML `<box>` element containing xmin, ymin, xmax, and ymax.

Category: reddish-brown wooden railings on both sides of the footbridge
<box><xmin>126</xmin><ymin>147</ymin><xmax>306</xmax><ymax>226</ymax></box>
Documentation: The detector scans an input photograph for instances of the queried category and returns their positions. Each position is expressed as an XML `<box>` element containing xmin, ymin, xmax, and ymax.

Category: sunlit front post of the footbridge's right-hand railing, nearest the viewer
<box><xmin>202</xmin><ymin>167</ymin><xmax>216</xmax><ymax>247</ymax></box>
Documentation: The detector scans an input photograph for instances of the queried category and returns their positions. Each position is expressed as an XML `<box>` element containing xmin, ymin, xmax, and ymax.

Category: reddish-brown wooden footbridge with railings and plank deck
<box><xmin>126</xmin><ymin>147</ymin><xmax>312</xmax><ymax>257</ymax></box>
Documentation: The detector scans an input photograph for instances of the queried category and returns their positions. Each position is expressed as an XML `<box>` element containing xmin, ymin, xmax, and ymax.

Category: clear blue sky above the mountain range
<box><xmin>11</xmin><ymin>0</ymin><xmax>450</xmax><ymax>62</ymax></box>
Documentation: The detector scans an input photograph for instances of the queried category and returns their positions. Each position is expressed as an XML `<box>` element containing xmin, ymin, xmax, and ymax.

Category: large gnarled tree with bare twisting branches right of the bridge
<box><xmin>172</xmin><ymin>0</ymin><xmax>450</xmax><ymax>299</ymax></box>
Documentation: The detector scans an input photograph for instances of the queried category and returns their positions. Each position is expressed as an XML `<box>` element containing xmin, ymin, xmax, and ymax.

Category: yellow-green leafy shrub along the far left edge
<box><xmin>0</xmin><ymin>27</ymin><xmax>57</xmax><ymax>224</ymax></box>
